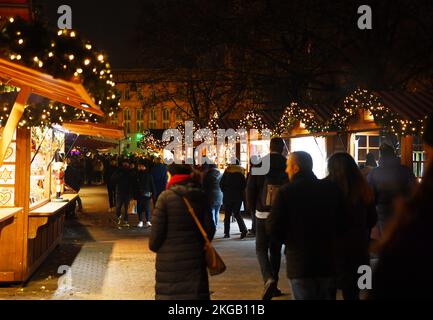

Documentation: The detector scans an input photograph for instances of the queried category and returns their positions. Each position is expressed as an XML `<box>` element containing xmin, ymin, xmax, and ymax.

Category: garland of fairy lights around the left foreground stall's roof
<box><xmin>0</xmin><ymin>17</ymin><xmax>120</xmax><ymax>128</ymax></box>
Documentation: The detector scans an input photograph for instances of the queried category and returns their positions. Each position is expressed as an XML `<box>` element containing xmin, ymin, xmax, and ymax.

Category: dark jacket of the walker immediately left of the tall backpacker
<box><xmin>220</xmin><ymin>165</ymin><xmax>247</xmax><ymax>204</ymax></box>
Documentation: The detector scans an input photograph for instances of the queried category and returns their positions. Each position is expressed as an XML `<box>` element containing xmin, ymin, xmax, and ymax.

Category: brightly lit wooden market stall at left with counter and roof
<box><xmin>0</xmin><ymin>59</ymin><xmax>103</xmax><ymax>283</ymax></box>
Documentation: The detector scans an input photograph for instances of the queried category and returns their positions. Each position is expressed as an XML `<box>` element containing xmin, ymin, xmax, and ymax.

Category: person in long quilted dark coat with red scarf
<box><xmin>149</xmin><ymin>165</ymin><xmax>215</xmax><ymax>300</ymax></box>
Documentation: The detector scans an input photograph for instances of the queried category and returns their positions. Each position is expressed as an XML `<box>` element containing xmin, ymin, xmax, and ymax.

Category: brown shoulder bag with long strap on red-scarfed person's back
<box><xmin>182</xmin><ymin>197</ymin><xmax>227</xmax><ymax>276</ymax></box>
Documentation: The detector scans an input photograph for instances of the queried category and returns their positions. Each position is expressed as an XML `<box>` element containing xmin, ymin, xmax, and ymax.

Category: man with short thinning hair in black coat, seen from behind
<box><xmin>267</xmin><ymin>152</ymin><xmax>344</xmax><ymax>300</ymax></box>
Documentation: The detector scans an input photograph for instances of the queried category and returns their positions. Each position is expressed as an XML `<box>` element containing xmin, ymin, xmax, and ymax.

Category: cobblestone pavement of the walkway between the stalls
<box><xmin>0</xmin><ymin>187</ymin><xmax>291</xmax><ymax>300</ymax></box>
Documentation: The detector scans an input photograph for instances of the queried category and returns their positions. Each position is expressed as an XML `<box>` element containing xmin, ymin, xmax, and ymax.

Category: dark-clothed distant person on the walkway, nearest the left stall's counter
<box><xmin>111</xmin><ymin>159</ymin><xmax>134</xmax><ymax>227</ymax></box>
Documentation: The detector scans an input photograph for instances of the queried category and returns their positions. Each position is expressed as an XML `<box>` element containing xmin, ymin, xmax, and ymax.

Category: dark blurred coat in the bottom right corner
<box><xmin>368</xmin><ymin>198</ymin><xmax>433</xmax><ymax>301</ymax></box>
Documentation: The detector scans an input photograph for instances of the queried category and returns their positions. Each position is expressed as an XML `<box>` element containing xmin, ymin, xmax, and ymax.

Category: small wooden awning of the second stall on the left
<box><xmin>62</xmin><ymin>121</ymin><xmax>125</xmax><ymax>140</ymax></box>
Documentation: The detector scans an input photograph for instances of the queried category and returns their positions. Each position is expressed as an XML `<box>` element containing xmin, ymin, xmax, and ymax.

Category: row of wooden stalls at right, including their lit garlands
<box><xmin>275</xmin><ymin>89</ymin><xmax>433</xmax><ymax>177</ymax></box>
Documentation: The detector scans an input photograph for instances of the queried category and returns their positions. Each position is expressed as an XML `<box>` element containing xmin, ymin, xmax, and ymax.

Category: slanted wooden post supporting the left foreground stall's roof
<box><xmin>0</xmin><ymin>87</ymin><xmax>31</xmax><ymax>166</ymax></box>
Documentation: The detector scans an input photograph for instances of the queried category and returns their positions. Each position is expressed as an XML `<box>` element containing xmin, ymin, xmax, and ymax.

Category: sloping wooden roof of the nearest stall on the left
<box><xmin>0</xmin><ymin>58</ymin><xmax>104</xmax><ymax>116</ymax></box>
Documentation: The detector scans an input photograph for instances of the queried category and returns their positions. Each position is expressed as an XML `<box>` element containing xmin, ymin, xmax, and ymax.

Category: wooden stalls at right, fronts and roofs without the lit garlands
<box><xmin>283</xmin><ymin>91</ymin><xmax>433</xmax><ymax>177</ymax></box>
